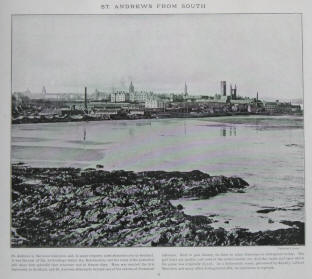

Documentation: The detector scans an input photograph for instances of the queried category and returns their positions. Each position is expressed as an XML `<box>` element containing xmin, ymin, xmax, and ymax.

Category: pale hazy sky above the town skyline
<box><xmin>12</xmin><ymin>14</ymin><xmax>303</xmax><ymax>99</ymax></box>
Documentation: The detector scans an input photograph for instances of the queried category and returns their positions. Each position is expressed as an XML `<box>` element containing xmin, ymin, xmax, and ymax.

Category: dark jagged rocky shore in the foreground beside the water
<box><xmin>11</xmin><ymin>165</ymin><xmax>304</xmax><ymax>247</ymax></box>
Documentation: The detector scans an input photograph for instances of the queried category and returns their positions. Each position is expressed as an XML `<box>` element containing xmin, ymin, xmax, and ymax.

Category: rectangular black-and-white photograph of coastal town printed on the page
<box><xmin>8</xmin><ymin>14</ymin><xmax>305</xmax><ymax>248</ymax></box>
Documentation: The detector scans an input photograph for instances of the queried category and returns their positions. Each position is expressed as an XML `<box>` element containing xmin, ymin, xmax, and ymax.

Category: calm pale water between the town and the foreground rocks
<box><xmin>12</xmin><ymin>116</ymin><xmax>304</xmax><ymax>231</ymax></box>
